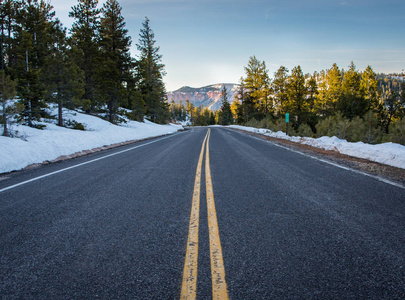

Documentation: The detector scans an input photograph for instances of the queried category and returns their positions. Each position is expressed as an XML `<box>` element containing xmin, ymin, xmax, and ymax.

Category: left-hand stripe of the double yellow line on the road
<box><xmin>180</xmin><ymin>131</ymin><xmax>209</xmax><ymax>300</ymax></box>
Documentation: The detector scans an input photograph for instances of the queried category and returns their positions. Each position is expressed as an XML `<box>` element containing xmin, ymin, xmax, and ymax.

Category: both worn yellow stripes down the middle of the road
<box><xmin>180</xmin><ymin>129</ymin><xmax>228</xmax><ymax>300</ymax></box>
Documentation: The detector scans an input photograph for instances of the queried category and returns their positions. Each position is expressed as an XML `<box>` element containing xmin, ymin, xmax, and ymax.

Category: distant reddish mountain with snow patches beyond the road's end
<box><xmin>167</xmin><ymin>83</ymin><xmax>239</xmax><ymax>110</ymax></box>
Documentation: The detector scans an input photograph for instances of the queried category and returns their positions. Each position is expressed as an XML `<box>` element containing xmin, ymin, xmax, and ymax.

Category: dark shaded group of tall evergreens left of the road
<box><xmin>0</xmin><ymin>0</ymin><xmax>170</xmax><ymax>136</ymax></box>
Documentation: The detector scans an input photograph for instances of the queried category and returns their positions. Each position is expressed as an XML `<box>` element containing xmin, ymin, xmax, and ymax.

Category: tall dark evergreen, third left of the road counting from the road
<box><xmin>69</xmin><ymin>0</ymin><xmax>102</xmax><ymax>112</ymax></box>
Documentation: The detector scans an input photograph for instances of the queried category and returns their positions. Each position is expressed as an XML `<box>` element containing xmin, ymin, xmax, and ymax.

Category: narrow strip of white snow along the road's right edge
<box><xmin>229</xmin><ymin>125</ymin><xmax>405</xmax><ymax>169</ymax></box>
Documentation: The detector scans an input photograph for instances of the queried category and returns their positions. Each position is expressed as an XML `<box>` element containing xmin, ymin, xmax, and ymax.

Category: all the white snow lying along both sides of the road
<box><xmin>0</xmin><ymin>108</ymin><xmax>405</xmax><ymax>173</ymax></box>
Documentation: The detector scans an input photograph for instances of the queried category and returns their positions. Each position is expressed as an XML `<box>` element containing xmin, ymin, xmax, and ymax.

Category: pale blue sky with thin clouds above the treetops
<box><xmin>48</xmin><ymin>0</ymin><xmax>405</xmax><ymax>91</ymax></box>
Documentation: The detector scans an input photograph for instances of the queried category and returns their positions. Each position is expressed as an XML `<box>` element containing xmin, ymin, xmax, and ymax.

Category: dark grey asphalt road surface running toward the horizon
<box><xmin>0</xmin><ymin>127</ymin><xmax>405</xmax><ymax>299</ymax></box>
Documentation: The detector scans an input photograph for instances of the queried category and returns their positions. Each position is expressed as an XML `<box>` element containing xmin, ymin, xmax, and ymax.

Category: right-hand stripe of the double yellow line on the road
<box><xmin>205</xmin><ymin>129</ymin><xmax>229</xmax><ymax>300</ymax></box>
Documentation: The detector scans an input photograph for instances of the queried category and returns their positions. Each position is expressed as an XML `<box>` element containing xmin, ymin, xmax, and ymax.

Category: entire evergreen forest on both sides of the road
<box><xmin>0</xmin><ymin>0</ymin><xmax>405</xmax><ymax>144</ymax></box>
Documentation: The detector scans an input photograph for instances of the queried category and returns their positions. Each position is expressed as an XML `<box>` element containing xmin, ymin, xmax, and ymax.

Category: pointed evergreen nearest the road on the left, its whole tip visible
<box><xmin>137</xmin><ymin>18</ymin><xmax>169</xmax><ymax>122</ymax></box>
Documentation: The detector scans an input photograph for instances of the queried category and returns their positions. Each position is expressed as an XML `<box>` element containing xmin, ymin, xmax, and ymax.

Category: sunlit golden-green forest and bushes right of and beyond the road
<box><xmin>171</xmin><ymin>56</ymin><xmax>405</xmax><ymax>145</ymax></box>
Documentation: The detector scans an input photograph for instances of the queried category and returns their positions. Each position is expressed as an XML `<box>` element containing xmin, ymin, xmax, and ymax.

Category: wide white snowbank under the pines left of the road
<box><xmin>0</xmin><ymin>108</ymin><xmax>183</xmax><ymax>173</ymax></box>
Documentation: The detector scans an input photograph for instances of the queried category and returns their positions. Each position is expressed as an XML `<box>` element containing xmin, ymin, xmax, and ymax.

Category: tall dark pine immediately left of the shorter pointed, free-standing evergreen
<box><xmin>99</xmin><ymin>0</ymin><xmax>132</xmax><ymax>122</ymax></box>
